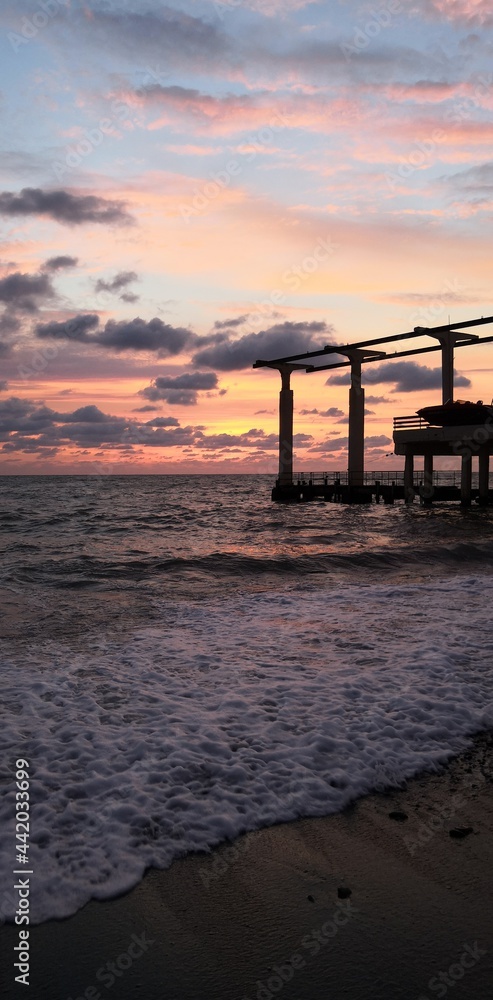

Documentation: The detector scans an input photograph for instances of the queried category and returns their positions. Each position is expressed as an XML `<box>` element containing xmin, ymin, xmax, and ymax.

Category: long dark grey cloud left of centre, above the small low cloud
<box><xmin>35</xmin><ymin>313</ymin><xmax>197</xmax><ymax>357</ymax></box>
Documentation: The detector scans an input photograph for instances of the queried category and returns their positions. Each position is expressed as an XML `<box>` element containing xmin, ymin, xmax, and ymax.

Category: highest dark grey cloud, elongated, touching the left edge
<box><xmin>0</xmin><ymin>188</ymin><xmax>132</xmax><ymax>226</ymax></box>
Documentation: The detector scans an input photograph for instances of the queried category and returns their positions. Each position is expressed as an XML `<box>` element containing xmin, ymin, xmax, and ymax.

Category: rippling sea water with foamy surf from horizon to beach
<box><xmin>0</xmin><ymin>476</ymin><xmax>493</xmax><ymax>922</ymax></box>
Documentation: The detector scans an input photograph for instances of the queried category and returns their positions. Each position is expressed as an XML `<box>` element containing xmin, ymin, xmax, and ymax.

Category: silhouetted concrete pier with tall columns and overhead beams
<box><xmin>253</xmin><ymin>316</ymin><xmax>493</xmax><ymax>506</ymax></box>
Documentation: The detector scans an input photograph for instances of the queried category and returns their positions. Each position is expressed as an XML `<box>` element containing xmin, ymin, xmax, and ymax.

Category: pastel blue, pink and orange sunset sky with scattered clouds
<box><xmin>0</xmin><ymin>0</ymin><xmax>493</xmax><ymax>476</ymax></box>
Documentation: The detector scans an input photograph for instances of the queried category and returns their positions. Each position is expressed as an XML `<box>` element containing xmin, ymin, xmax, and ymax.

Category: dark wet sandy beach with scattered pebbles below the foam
<box><xmin>2</xmin><ymin>733</ymin><xmax>493</xmax><ymax>1000</ymax></box>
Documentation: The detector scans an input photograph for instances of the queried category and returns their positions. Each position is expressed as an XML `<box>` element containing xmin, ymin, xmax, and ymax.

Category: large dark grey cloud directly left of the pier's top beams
<box><xmin>193</xmin><ymin>322</ymin><xmax>332</xmax><ymax>371</ymax></box>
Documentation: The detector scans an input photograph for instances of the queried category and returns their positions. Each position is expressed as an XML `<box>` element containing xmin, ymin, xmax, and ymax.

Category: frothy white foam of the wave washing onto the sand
<box><xmin>0</xmin><ymin>577</ymin><xmax>493</xmax><ymax>922</ymax></box>
